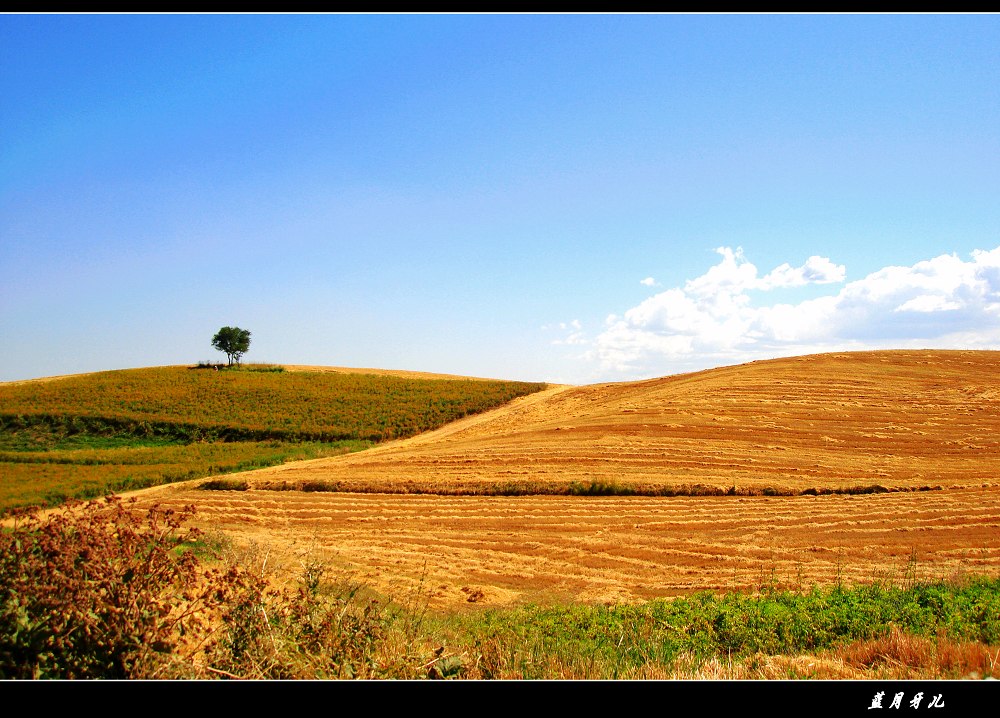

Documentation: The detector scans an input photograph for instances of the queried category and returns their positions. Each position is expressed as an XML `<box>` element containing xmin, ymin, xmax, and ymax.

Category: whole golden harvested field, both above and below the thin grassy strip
<box><xmin>138</xmin><ymin>351</ymin><xmax>1000</xmax><ymax>605</ymax></box>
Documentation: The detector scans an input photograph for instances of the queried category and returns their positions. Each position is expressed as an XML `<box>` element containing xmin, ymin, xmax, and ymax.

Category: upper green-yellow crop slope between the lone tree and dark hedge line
<box><xmin>0</xmin><ymin>367</ymin><xmax>542</xmax><ymax>441</ymax></box>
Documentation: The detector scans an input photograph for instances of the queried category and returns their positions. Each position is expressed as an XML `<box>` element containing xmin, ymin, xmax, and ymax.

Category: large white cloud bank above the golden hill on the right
<box><xmin>580</xmin><ymin>247</ymin><xmax>1000</xmax><ymax>376</ymax></box>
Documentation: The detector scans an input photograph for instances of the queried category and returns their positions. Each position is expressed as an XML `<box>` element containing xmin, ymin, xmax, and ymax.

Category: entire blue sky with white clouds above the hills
<box><xmin>0</xmin><ymin>14</ymin><xmax>1000</xmax><ymax>383</ymax></box>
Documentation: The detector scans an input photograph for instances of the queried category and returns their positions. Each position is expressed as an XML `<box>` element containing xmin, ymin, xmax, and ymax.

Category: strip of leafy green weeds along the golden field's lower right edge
<box><xmin>452</xmin><ymin>578</ymin><xmax>1000</xmax><ymax>678</ymax></box>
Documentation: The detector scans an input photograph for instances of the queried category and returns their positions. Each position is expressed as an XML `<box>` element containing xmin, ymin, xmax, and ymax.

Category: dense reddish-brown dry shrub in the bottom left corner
<box><xmin>0</xmin><ymin>497</ymin><xmax>225</xmax><ymax>678</ymax></box>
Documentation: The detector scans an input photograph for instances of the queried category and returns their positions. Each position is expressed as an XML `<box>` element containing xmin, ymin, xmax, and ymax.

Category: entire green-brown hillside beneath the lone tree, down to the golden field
<box><xmin>0</xmin><ymin>365</ymin><xmax>544</xmax><ymax>515</ymax></box>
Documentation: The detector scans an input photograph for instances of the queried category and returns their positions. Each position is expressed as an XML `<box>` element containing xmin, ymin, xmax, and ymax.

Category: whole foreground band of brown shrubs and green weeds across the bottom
<box><xmin>0</xmin><ymin>497</ymin><xmax>1000</xmax><ymax>679</ymax></box>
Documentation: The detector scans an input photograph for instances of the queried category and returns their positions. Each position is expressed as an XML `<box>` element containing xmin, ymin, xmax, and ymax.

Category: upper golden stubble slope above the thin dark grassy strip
<box><xmin>203</xmin><ymin>350</ymin><xmax>1000</xmax><ymax>492</ymax></box>
